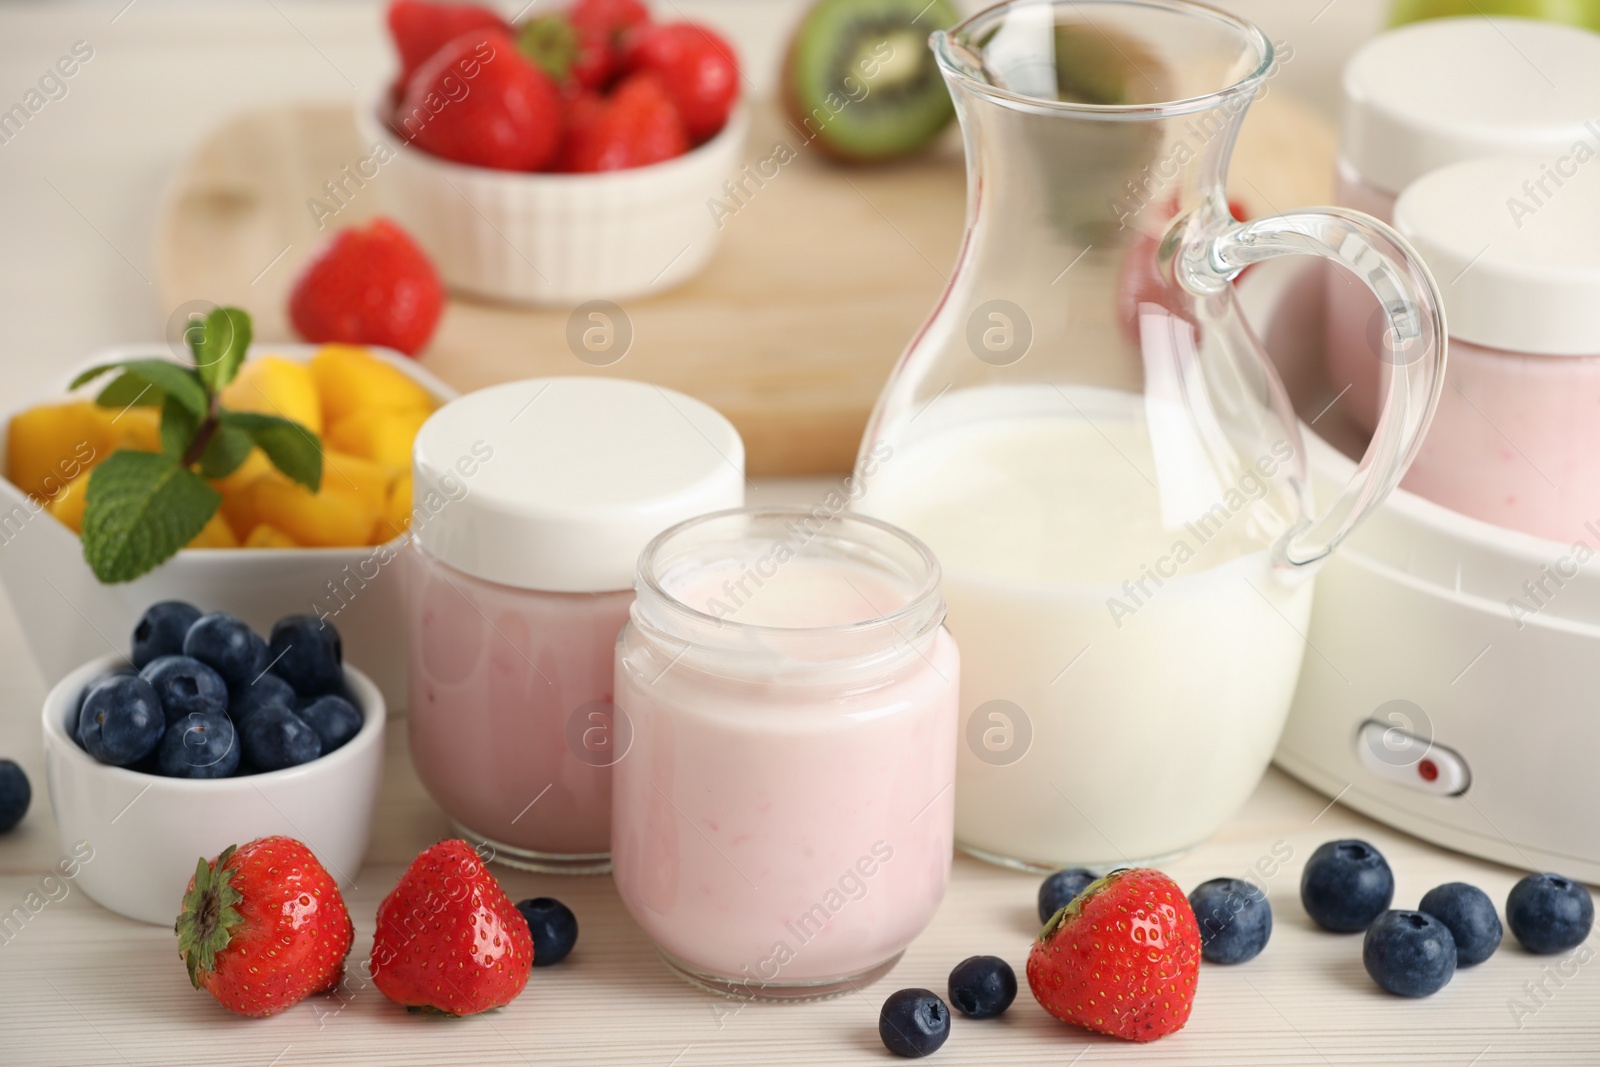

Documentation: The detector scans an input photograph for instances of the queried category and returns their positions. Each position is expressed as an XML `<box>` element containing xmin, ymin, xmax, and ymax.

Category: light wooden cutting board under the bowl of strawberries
<box><xmin>157</xmin><ymin>91</ymin><xmax>1334</xmax><ymax>477</ymax></box>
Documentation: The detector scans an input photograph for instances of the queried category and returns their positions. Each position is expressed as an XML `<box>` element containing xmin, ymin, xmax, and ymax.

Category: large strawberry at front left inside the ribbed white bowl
<box><xmin>390</xmin><ymin>30</ymin><xmax>562</xmax><ymax>171</ymax></box>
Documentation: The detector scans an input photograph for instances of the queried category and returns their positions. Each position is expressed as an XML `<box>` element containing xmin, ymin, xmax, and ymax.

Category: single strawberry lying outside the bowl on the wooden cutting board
<box><xmin>290</xmin><ymin>219</ymin><xmax>445</xmax><ymax>355</ymax></box>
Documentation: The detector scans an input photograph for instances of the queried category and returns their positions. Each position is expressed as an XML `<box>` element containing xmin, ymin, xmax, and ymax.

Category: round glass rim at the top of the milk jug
<box><xmin>930</xmin><ymin>0</ymin><xmax>1277</xmax><ymax>118</ymax></box>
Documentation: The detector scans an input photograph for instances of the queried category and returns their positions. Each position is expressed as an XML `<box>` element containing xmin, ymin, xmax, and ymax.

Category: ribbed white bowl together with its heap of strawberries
<box><xmin>369</xmin><ymin>0</ymin><xmax>749</xmax><ymax>304</ymax></box>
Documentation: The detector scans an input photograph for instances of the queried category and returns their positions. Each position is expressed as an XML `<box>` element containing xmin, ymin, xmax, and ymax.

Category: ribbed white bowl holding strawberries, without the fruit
<box><xmin>357</xmin><ymin>96</ymin><xmax>749</xmax><ymax>304</ymax></box>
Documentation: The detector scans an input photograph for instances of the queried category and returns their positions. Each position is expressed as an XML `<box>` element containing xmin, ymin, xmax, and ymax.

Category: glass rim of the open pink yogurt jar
<box><xmin>637</xmin><ymin>506</ymin><xmax>944</xmax><ymax>640</ymax></box>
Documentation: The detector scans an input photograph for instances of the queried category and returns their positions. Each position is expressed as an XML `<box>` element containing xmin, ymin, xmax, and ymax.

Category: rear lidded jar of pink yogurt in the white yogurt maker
<box><xmin>1325</xmin><ymin>16</ymin><xmax>1600</xmax><ymax>434</ymax></box>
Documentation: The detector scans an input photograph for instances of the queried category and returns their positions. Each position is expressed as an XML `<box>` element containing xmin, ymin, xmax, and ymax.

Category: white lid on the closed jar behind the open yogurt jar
<box><xmin>411</xmin><ymin>378</ymin><xmax>744</xmax><ymax>593</ymax></box>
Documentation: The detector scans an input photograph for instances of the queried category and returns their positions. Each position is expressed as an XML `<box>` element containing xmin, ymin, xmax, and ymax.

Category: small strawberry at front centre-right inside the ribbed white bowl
<box><xmin>562</xmin><ymin>74</ymin><xmax>690</xmax><ymax>173</ymax></box>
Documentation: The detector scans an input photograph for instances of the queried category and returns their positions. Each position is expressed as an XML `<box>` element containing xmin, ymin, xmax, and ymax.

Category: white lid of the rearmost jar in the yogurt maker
<box><xmin>1339</xmin><ymin>16</ymin><xmax>1600</xmax><ymax>194</ymax></box>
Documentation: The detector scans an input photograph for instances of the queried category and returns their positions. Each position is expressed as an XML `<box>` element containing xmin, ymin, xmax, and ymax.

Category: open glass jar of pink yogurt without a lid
<box><xmin>611</xmin><ymin>507</ymin><xmax>960</xmax><ymax>1000</ymax></box>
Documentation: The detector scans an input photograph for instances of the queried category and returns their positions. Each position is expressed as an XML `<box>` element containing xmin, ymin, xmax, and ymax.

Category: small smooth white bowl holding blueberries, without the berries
<box><xmin>43</xmin><ymin>654</ymin><xmax>384</xmax><ymax>926</ymax></box>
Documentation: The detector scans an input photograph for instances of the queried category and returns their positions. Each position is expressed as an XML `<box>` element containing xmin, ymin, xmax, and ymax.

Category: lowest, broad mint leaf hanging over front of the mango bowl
<box><xmin>83</xmin><ymin>451</ymin><xmax>222</xmax><ymax>584</ymax></box>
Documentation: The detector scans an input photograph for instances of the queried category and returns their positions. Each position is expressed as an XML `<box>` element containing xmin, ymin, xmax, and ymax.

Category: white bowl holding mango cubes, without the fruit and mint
<box><xmin>0</xmin><ymin>344</ymin><xmax>456</xmax><ymax>709</ymax></box>
